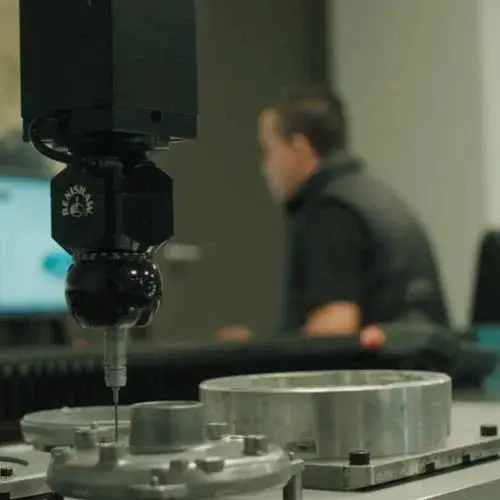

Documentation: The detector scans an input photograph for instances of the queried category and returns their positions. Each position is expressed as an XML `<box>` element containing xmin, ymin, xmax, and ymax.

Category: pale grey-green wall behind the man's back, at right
<box><xmin>328</xmin><ymin>0</ymin><xmax>486</xmax><ymax>323</ymax></box>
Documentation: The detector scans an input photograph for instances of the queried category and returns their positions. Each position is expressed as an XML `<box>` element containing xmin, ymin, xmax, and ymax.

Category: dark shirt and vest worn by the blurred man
<box><xmin>278</xmin><ymin>155</ymin><xmax>447</xmax><ymax>334</ymax></box>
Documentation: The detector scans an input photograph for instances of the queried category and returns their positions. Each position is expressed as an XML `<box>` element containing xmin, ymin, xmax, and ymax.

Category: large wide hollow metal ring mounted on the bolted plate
<box><xmin>200</xmin><ymin>371</ymin><xmax>452</xmax><ymax>459</ymax></box>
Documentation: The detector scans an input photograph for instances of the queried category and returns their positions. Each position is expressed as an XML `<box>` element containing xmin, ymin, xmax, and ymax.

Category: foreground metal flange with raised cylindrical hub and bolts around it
<box><xmin>47</xmin><ymin>402</ymin><xmax>303</xmax><ymax>500</ymax></box>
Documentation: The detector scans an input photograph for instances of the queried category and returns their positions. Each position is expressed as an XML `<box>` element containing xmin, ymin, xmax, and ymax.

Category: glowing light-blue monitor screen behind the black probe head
<box><xmin>0</xmin><ymin>173</ymin><xmax>71</xmax><ymax>315</ymax></box>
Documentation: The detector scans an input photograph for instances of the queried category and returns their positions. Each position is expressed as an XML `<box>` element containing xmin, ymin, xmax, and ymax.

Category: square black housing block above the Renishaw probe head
<box><xmin>20</xmin><ymin>0</ymin><xmax>197</xmax><ymax>145</ymax></box>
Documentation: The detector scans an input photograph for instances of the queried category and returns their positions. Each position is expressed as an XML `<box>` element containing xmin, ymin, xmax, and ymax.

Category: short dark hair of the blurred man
<box><xmin>271</xmin><ymin>87</ymin><xmax>347</xmax><ymax>158</ymax></box>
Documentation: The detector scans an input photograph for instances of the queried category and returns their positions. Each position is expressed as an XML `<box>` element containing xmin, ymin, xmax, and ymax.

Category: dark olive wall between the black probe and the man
<box><xmin>152</xmin><ymin>0</ymin><xmax>326</xmax><ymax>342</ymax></box>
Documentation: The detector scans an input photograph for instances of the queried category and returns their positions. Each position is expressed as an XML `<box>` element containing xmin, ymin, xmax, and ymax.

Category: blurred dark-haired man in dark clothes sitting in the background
<box><xmin>220</xmin><ymin>88</ymin><xmax>448</xmax><ymax>340</ymax></box>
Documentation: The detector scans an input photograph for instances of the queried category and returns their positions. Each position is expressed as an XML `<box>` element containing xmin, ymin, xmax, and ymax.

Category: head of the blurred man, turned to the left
<box><xmin>259</xmin><ymin>87</ymin><xmax>346</xmax><ymax>201</ymax></box>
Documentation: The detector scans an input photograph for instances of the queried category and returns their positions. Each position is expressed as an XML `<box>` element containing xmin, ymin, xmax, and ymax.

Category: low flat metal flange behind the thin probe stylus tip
<box><xmin>21</xmin><ymin>406</ymin><xmax>130</xmax><ymax>451</ymax></box>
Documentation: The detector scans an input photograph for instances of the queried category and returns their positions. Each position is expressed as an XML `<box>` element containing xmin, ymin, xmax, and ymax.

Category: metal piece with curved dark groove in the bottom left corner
<box><xmin>0</xmin><ymin>445</ymin><xmax>50</xmax><ymax>500</ymax></box>
